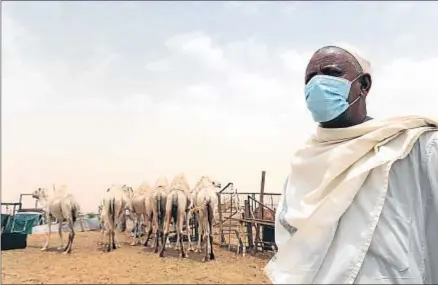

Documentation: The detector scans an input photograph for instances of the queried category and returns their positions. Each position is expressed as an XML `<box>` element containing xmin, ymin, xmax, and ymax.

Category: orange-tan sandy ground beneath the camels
<box><xmin>1</xmin><ymin>232</ymin><xmax>270</xmax><ymax>284</ymax></box>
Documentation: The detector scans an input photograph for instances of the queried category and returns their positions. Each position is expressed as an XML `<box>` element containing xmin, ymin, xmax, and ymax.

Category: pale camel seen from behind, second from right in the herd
<box><xmin>159</xmin><ymin>173</ymin><xmax>191</xmax><ymax>258</ymax></box>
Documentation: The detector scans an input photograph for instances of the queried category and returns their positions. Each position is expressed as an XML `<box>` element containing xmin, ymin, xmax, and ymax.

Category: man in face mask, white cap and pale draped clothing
<box><xmin>265</xmin><ymin>46</ymin><xmax>438</xmax><ymax>284</ymax></box>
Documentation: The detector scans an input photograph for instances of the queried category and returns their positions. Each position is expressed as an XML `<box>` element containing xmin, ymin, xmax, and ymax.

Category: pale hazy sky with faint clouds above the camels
<box><xmin>1</xmin><ymin>1</ymin><xmax>438</xmax><ymax>211</ymax></box>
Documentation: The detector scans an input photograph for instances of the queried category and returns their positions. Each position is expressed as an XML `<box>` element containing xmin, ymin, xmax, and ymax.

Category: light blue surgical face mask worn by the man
<box><xmin>304</xmin><ymin>75</ymin><xmax>360</xmax><ymax>123</ymax></box>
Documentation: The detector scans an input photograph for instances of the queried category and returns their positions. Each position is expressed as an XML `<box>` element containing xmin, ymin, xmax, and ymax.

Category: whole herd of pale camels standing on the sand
<box><xmin>33</xmin><ymin>174</ymin><xmax>221</xmax><ymax>261</ymax></box>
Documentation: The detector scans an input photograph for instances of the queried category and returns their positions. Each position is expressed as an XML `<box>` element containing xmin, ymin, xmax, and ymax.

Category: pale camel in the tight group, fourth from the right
<box><xmin>128</xmin><ymin>182</ymin><xmax>152</xmax><ymax>246</ymax></box>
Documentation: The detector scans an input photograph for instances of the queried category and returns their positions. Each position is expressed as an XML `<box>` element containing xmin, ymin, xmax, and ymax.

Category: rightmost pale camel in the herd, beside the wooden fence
<box><xmin>191</xmin><ymin>176</ymin><xmax>221</xmax><ymax>262</ymax></box>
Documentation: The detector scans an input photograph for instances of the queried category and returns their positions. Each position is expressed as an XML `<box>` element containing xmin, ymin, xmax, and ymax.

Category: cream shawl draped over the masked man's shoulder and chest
<box><xmin>265</xmin><ymin>116</ymin><xmax>438</xmax><ymax>284</ymax></box>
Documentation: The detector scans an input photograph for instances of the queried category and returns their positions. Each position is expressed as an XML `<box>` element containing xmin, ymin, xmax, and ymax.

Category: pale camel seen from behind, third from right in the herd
<box><xmin>144</xmin><ymin>176</ymin><xmax>169</xmax><ymax>253</ymax></box>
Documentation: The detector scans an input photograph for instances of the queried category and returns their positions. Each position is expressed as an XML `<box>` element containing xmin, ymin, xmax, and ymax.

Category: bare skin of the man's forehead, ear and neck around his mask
<box><xmin>305</xmin><ymin>47</ymin><xmax>372</xmax><ymax>128</ymax></box>
